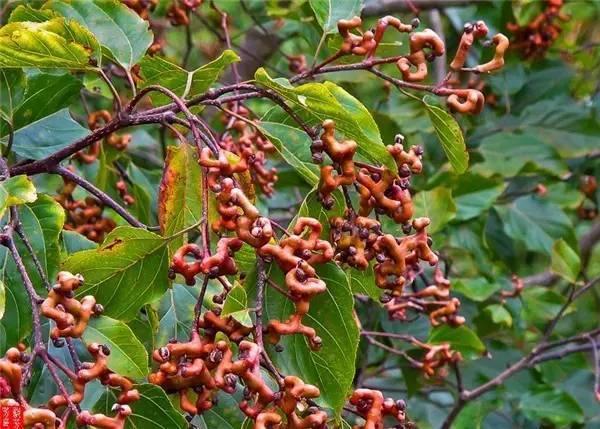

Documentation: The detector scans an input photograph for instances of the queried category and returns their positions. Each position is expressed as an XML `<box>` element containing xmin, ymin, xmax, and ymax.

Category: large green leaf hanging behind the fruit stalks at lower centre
<box><xmin>265</xmin><ymin>264</ymin><xmax>359</xmax><ymax>416</ymax></box>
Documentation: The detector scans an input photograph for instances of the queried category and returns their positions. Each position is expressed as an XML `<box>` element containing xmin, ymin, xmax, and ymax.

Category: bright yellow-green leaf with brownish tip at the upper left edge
<box><xmin>0</xmin><ymin>18</ymin><xmax>97</xmax><ymax>70</ymax></box>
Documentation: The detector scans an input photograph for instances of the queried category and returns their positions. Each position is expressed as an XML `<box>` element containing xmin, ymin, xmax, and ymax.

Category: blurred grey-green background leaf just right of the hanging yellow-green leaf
<box><xmin>473</xmin><ymin>132</ymin><xmax>568</xmax><ymax>177</ymax></box>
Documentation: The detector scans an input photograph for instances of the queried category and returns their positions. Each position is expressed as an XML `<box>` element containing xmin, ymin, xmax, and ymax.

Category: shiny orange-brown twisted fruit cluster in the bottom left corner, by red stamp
<box><xmin>0</xmin><ymin>271</ymin><xmax>140</xmax><ymax>429</ymax></box>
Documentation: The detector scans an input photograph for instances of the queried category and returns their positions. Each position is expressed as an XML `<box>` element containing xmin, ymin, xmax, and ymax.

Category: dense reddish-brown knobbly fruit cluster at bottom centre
<box><xmin>149</xmin><ymin>311</ymin><xmax>327</xmax><ymax>422</ymax></box>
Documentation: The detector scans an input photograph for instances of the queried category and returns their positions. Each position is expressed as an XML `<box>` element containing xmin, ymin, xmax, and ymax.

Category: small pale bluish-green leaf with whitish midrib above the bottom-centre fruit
<box><xmin>156</xmin><ymin>284</ymin><xmax>198</xmax><ymax>344</ymax></box>
